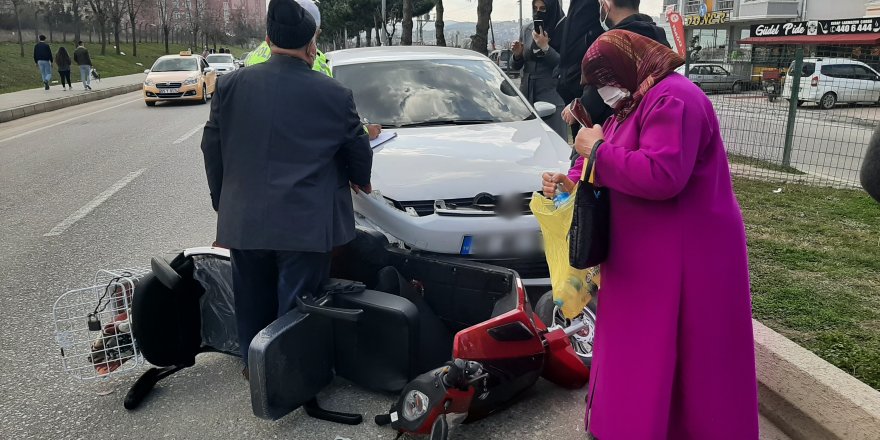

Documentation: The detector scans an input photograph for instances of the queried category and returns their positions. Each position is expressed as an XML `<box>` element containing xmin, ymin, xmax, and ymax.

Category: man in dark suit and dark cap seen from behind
<box><xmin>202</xmin><ymin>0</ymin><xmax>372</xmax><ymax>375</ymax></box>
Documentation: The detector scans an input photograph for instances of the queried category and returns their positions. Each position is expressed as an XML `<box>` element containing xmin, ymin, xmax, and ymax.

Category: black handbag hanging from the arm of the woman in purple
<box><xmin>568</xmin><ymin>144</ymin><xmax>611</xmax><ymax>269</ymax></box>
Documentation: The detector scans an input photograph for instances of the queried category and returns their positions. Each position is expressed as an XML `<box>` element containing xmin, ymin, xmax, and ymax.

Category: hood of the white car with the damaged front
<box><xmin>372</xmin><ymin>120</ymin><xmax>571</xmax><ymax>201</ymax></box>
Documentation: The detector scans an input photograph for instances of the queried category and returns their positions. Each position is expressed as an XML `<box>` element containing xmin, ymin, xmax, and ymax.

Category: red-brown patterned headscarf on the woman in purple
<box><xmin>581</xmin><ymin>30</ymin><xmax>684</xmax><ymax>122</ymax></box>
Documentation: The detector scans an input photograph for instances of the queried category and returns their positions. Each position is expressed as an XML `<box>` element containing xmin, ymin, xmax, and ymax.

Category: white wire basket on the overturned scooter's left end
<box><xmin>52</xmin><ymin>268</ymin><xmax>150</xmax><ymax>380</ymax></box>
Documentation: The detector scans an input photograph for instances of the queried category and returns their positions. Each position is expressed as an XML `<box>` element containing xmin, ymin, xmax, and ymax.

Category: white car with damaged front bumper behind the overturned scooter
<box><xmin>328</xmin><ymin>47</ymin><xmax>571</xmax><ymax>291</ymax></box>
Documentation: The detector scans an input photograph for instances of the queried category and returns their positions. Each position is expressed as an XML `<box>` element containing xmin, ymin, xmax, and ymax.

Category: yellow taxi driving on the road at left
<box><xmin>144</xmin><ymin>52</ymin><xmax>217</xmax><ymax>107</ymax></box>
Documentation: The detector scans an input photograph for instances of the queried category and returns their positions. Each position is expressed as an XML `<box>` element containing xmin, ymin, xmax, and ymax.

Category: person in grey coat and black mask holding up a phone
<box><xmin>513</xmin><ymin>0</ymin><xmax>568</xmax><ymax>141</ymax></box>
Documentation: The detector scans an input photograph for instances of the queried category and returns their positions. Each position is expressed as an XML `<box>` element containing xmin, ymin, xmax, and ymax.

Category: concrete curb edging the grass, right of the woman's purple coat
<box><xmin>752</xmin><ymin>320</ymin><xmax>880</xmax><ymax>440</ymax></box>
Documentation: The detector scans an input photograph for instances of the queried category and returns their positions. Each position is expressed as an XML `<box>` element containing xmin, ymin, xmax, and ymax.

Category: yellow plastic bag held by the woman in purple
<box><xmin>529</xmin><ymin>187</ymin><xmax>598</xmax><ymax>318</ymax></box>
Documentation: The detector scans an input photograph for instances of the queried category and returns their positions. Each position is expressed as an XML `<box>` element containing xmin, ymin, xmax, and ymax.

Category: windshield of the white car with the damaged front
<box><xmin>333</xmin><ymin>60</ymin><xmax>533</xmax><ymax>127</ymax></box>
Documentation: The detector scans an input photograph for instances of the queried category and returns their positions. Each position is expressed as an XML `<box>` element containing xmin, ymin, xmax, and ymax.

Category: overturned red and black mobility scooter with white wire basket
<box><xmin>55</xmin><ymin>230</ymin><xmax>589</xmax><ymax>438</ymax></box>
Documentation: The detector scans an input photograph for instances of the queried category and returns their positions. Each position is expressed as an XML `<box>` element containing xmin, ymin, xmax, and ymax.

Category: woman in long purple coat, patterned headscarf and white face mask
<box><xmin>544</xmin><ymin>31</ymin><xmax>758</xmax><ymax>440</ymax></box>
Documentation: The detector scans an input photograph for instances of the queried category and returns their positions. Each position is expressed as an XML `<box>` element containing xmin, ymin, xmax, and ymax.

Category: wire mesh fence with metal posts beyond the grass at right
<box><xmin>684</xmin><ymin>46</ymin><xmax>880</xmax><ymax>187</ymax></box>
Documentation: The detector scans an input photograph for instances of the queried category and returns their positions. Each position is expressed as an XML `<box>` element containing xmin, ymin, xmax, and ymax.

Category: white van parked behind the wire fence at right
<box><xmin>782</xmin><ymin>58</ymin><xmax>880</xmax><ymax>110</ymax></box>
